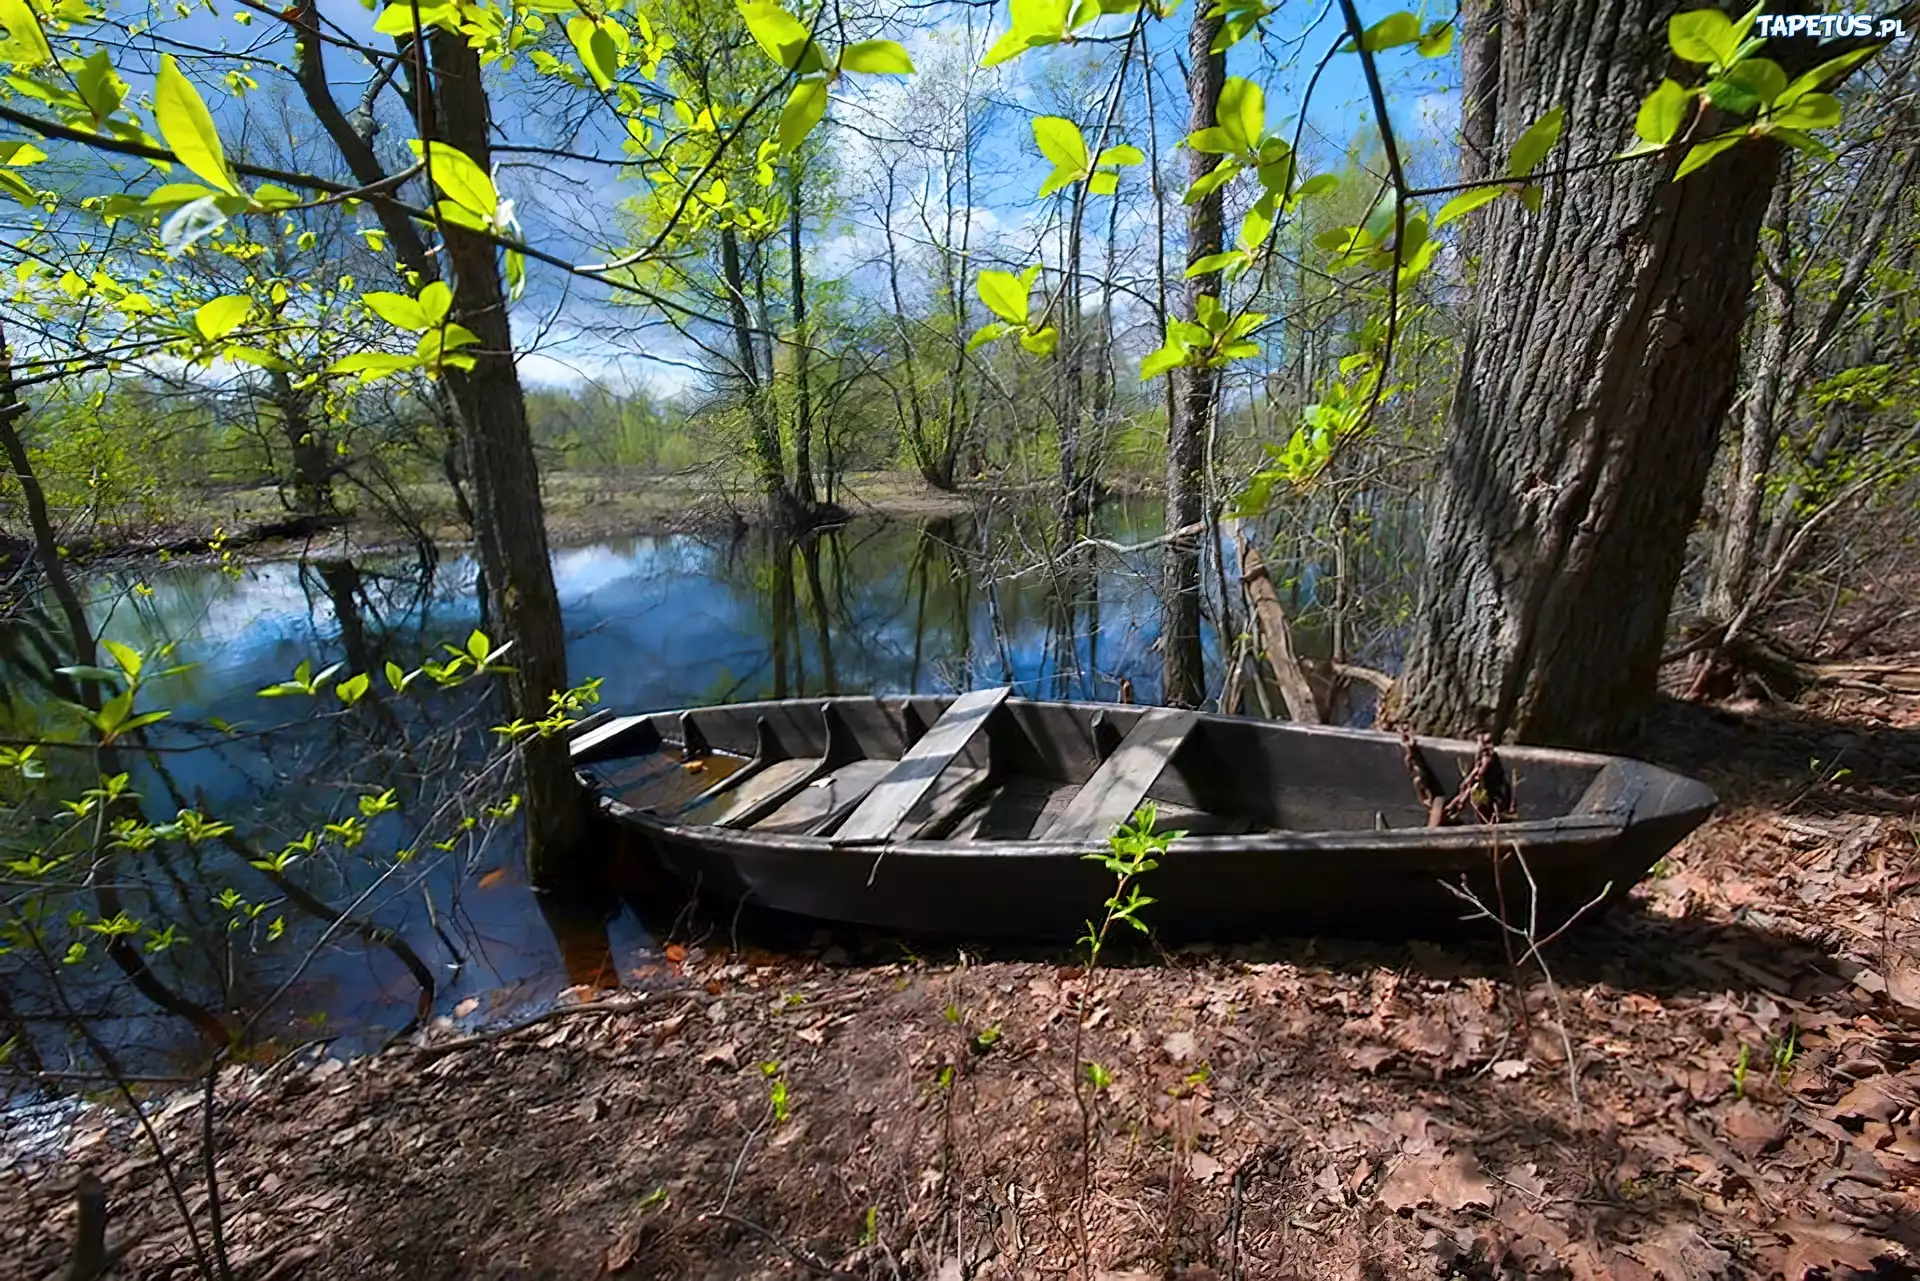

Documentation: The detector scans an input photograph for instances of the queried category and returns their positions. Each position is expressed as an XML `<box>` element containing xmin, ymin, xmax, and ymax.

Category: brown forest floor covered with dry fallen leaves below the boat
<box><xmin>0</xmin><ymin>676</ymin><xmax>1920</xmax><ymax>1281</ymax></box>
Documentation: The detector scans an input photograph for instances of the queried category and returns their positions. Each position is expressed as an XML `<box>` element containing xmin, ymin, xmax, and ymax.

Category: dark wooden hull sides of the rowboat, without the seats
<box><xmin>576</xmin><ymin>705</ymin><xmax>1715</xmax><ymax>939</ymax></box>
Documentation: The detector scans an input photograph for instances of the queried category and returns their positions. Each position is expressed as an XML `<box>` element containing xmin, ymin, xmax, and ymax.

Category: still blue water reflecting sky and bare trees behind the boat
<box><xmin>0</xmin><ymin>503</ymin><xmax>1413</xmax><ymax>1070</ymax></box>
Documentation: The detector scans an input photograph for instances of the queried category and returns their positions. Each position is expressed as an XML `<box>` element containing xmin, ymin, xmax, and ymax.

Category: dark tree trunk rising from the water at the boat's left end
<box><xmin>430</xmin><ymin>33</ymin><xmax>586</xmax><ymax>887</ymax></box>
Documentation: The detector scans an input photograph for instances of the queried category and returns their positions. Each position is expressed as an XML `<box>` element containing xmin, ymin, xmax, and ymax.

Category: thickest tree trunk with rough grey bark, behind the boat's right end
<box><xmin>1398</xmin><ymin>0</ymin><xmax>1780</xmax><ymax>745</ymax></box>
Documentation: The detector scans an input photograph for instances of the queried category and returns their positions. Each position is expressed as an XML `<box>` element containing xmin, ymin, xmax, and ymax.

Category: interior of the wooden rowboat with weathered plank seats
<box><xmin>572</xmin><ymin>688</ymin><xmax>1613</xmax><ymax>845</ymax></box>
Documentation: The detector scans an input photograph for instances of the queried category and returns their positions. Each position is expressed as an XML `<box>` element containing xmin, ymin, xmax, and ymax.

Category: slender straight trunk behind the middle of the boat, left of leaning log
<box><xmin>1160</xmin><ymin>4</ymin><xmax>1227</xmax><ymax>707</ymax></box>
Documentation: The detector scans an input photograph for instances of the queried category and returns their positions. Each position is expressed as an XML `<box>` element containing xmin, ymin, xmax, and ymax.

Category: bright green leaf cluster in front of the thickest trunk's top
<box><xmin>1620</xmin><ymin>6</ymin><xmax>1878</xmax><ymax>181</ymax></box>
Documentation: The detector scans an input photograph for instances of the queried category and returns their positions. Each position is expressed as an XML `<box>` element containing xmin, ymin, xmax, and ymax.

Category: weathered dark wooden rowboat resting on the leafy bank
<box><xmin>572</xmin><ymin>689</ymin><xmax>1715</xmax><ymax>939</ymax></box>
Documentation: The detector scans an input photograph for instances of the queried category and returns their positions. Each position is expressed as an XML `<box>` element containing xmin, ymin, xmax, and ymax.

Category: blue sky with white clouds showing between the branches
<box><xmin>3</xmin><ymin>0</ymin><xmax>1457</xmax><ymax>392</ymax></box>
